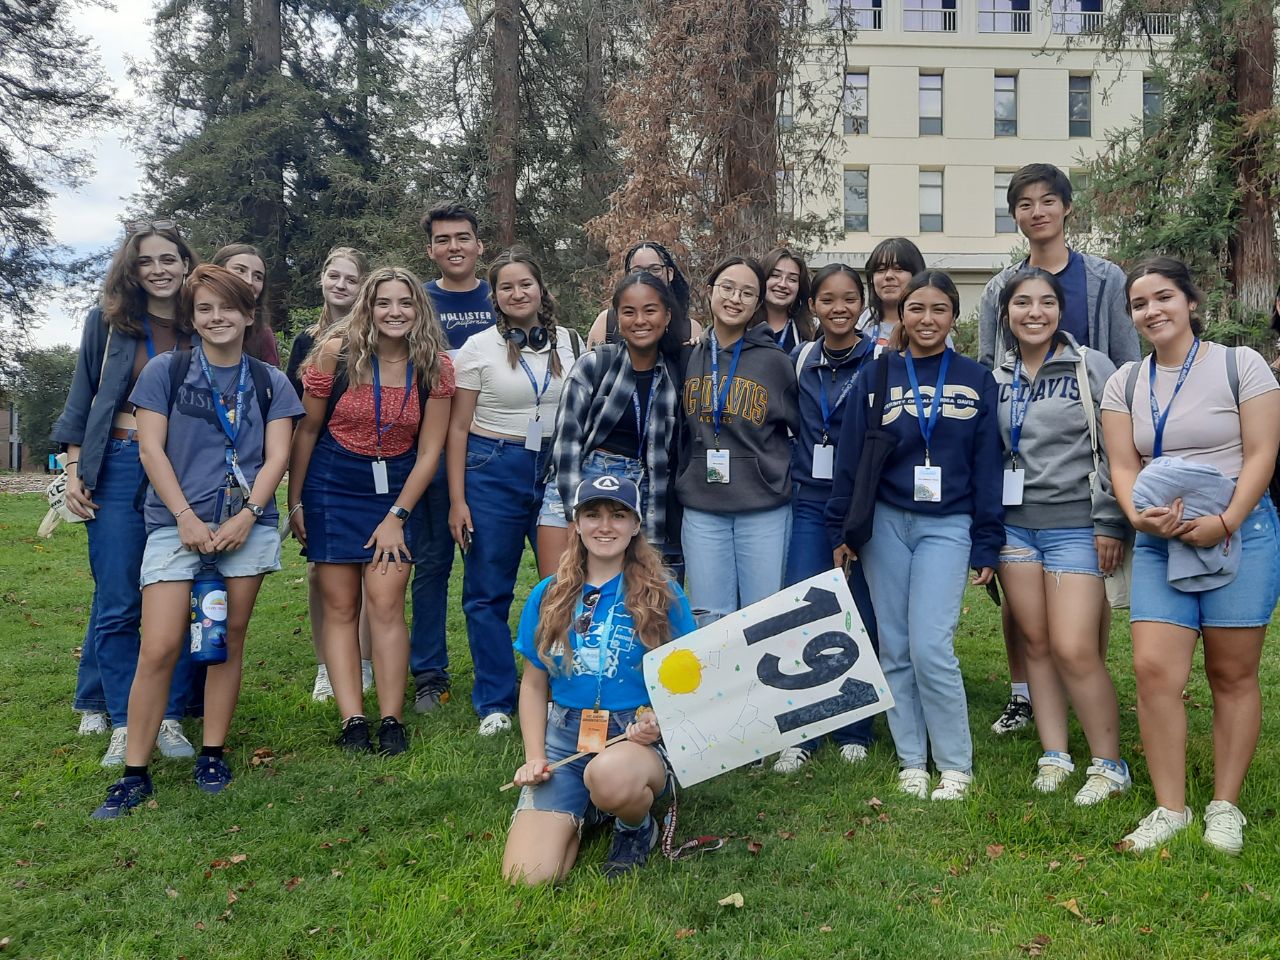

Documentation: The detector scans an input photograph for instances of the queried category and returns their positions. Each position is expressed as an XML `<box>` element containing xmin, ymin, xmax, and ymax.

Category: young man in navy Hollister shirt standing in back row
<box><xmin>410</xmin><ymin>204</ymin><xmax>494</xmax><ymax>713</ymax></box>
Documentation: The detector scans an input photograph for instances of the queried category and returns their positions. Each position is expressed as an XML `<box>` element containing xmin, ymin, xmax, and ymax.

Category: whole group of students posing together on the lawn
<box><xmin>55</xmin><ymin>164</ymin><xmax>1280</xmax><ymax>882</ymax></box>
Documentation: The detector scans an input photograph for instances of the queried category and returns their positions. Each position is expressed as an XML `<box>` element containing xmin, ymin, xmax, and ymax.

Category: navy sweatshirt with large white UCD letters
<box><xmin>827</xmin><ymin>351</ymin><xmax>1005</xmax><ymax>570</ymax></box>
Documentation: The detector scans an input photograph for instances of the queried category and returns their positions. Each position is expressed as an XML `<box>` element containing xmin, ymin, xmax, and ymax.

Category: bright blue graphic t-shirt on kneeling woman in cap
<box><xmin>516</xmin><ymin>573</ymin><xmax>698</xmax><ymax>710</ymax></box>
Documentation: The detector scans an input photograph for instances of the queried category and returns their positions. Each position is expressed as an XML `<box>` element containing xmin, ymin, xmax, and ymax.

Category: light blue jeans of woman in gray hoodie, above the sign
<box><xmin>681</xmin><ymin>503</ymin><xmax>791</xmax><ymax>627</ymax></box>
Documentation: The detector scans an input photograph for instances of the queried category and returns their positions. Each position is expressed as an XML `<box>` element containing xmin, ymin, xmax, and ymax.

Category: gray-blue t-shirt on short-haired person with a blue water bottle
<box><xmin>129</xmin><ymin>347</ymin><xmax>305</xmax><ymax>534</ymax></box>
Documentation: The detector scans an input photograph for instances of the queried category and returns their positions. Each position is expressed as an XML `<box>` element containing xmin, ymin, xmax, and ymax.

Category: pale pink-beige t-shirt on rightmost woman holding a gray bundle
<box><xmin>1102</xmin><ymin>340</ymin><xmax>1280</xmax><ymax>480</ymax></box>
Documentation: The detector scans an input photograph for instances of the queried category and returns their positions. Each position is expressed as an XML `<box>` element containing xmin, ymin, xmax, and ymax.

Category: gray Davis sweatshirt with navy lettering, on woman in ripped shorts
<box><xmin>992</xmin><ymin>332</ymin><xmax>1129</xmax><ymax>540</ymax></box>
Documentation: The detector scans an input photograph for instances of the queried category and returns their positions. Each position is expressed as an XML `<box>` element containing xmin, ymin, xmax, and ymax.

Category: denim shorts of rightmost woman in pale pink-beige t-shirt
<box><xmin>1129</xmin><ymin>495</ymin><xmax>1280</xmax><ymax>631</ymax></box>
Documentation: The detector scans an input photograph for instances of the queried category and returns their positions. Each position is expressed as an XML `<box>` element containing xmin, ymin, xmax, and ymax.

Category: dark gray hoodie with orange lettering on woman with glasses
<box><xmin>676</xmin><ymin>324</ymin><xmax>799</xmax><ymax>513</ymax></box>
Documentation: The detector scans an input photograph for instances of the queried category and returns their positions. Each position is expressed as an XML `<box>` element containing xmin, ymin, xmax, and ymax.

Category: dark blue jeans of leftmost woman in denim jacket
<box><xmin>74</xmin><ymin>440</ymin><xmax>193</xmax><ymax>727</ymax></box>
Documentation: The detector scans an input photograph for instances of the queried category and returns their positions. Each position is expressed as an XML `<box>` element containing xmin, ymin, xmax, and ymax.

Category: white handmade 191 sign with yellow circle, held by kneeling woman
<box><xmin>644</xmin><ymin>570</ymin><xmax>893</xmax><ymax>787</ymax></box>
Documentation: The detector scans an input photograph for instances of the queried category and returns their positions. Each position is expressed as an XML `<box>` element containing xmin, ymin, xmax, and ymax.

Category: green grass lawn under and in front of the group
<box><xmin>0</xmin><ymin>495</ymin><xmax>1280</xmax><ymax>960</ymax></box>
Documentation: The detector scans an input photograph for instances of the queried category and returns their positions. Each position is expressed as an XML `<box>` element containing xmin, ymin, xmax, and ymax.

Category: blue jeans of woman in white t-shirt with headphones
<box><xmin>462</xmin><ymin>434</ymin><xmax>549</xmax><ymax>717</ymax></box>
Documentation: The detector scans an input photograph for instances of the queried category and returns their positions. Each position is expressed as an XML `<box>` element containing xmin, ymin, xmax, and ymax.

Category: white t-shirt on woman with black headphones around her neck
<box><xmin>453</xmin><ymin>324</ymin><xmax>573</xmax><ymax>438</ymax></box>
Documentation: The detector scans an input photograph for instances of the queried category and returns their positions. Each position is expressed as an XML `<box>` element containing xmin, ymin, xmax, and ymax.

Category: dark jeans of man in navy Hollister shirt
<box><xmin>408</xmin><ymin>465</ymin><xmax>454</xmax><ymax>690</ymax></box>
